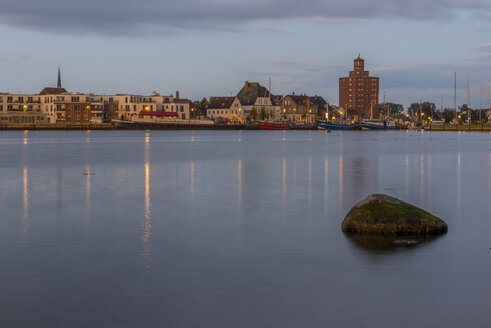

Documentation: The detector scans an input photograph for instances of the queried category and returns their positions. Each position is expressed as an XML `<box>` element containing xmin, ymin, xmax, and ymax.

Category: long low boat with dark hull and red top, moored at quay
<box><xmin>112</xmin><ymin>111</ymin><xmax>245</xmax><ymax>130</ymax></box>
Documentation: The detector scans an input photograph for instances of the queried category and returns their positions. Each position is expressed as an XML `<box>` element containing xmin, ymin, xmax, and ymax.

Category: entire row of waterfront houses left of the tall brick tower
<box><xmin>0</xmin><ymin>70</ymin><xmax>329</xmax><ymax>124</ymax></box>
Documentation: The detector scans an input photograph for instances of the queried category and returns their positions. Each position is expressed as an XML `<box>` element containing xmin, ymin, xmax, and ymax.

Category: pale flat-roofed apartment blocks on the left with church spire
<box><xmin>0</xmin><ymin>70</ymin><xmax>193</xmax><ymax>124</ymax></box>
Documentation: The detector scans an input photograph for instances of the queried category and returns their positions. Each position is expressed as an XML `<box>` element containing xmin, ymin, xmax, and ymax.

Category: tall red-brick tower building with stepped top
<box><xmin>339</xmin><ymin>55</ymin><xmax>379</xmax><ymax>119</ymax></box>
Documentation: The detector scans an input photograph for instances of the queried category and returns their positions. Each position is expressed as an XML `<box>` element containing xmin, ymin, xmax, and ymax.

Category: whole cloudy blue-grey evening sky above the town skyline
<box><xmin>0</xmin><ymin>0</ymin><xmax>491</xmax><ymax>108</ymax></box>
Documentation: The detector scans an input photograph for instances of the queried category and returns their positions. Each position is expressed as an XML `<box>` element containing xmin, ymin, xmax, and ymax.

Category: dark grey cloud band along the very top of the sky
<box><xmin>0</xmin><ymin>0</ymin><xmax>491</xmax><ymax>36</ymax></box>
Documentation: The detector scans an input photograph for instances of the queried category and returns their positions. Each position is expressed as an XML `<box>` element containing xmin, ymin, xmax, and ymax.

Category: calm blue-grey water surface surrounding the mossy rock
<box><xmin>0</xmin><ymin>131</ymin><xmax>491</xmax><ymax>328</ymax></box>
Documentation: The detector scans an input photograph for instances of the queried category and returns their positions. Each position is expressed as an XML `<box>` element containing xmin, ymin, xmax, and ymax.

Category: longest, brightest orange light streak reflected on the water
<box><xmin>142</xmin><ymin>133</ymin><xmax>152</xmax><ymax>268</ymax></box>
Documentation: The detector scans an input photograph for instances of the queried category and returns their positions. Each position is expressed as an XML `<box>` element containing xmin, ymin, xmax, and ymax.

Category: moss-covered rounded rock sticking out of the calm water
<box><xmin>342</xmin><ymin>194</ymin><xmax>448</xmax><ymax>235</ymax></box>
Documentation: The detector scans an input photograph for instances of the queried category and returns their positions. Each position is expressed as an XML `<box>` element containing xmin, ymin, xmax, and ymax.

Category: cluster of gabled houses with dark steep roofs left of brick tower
<box><xmin>206</xmin><ymin>81</ymin><xmax>329</xmax><ymax>123</ymax></box>
